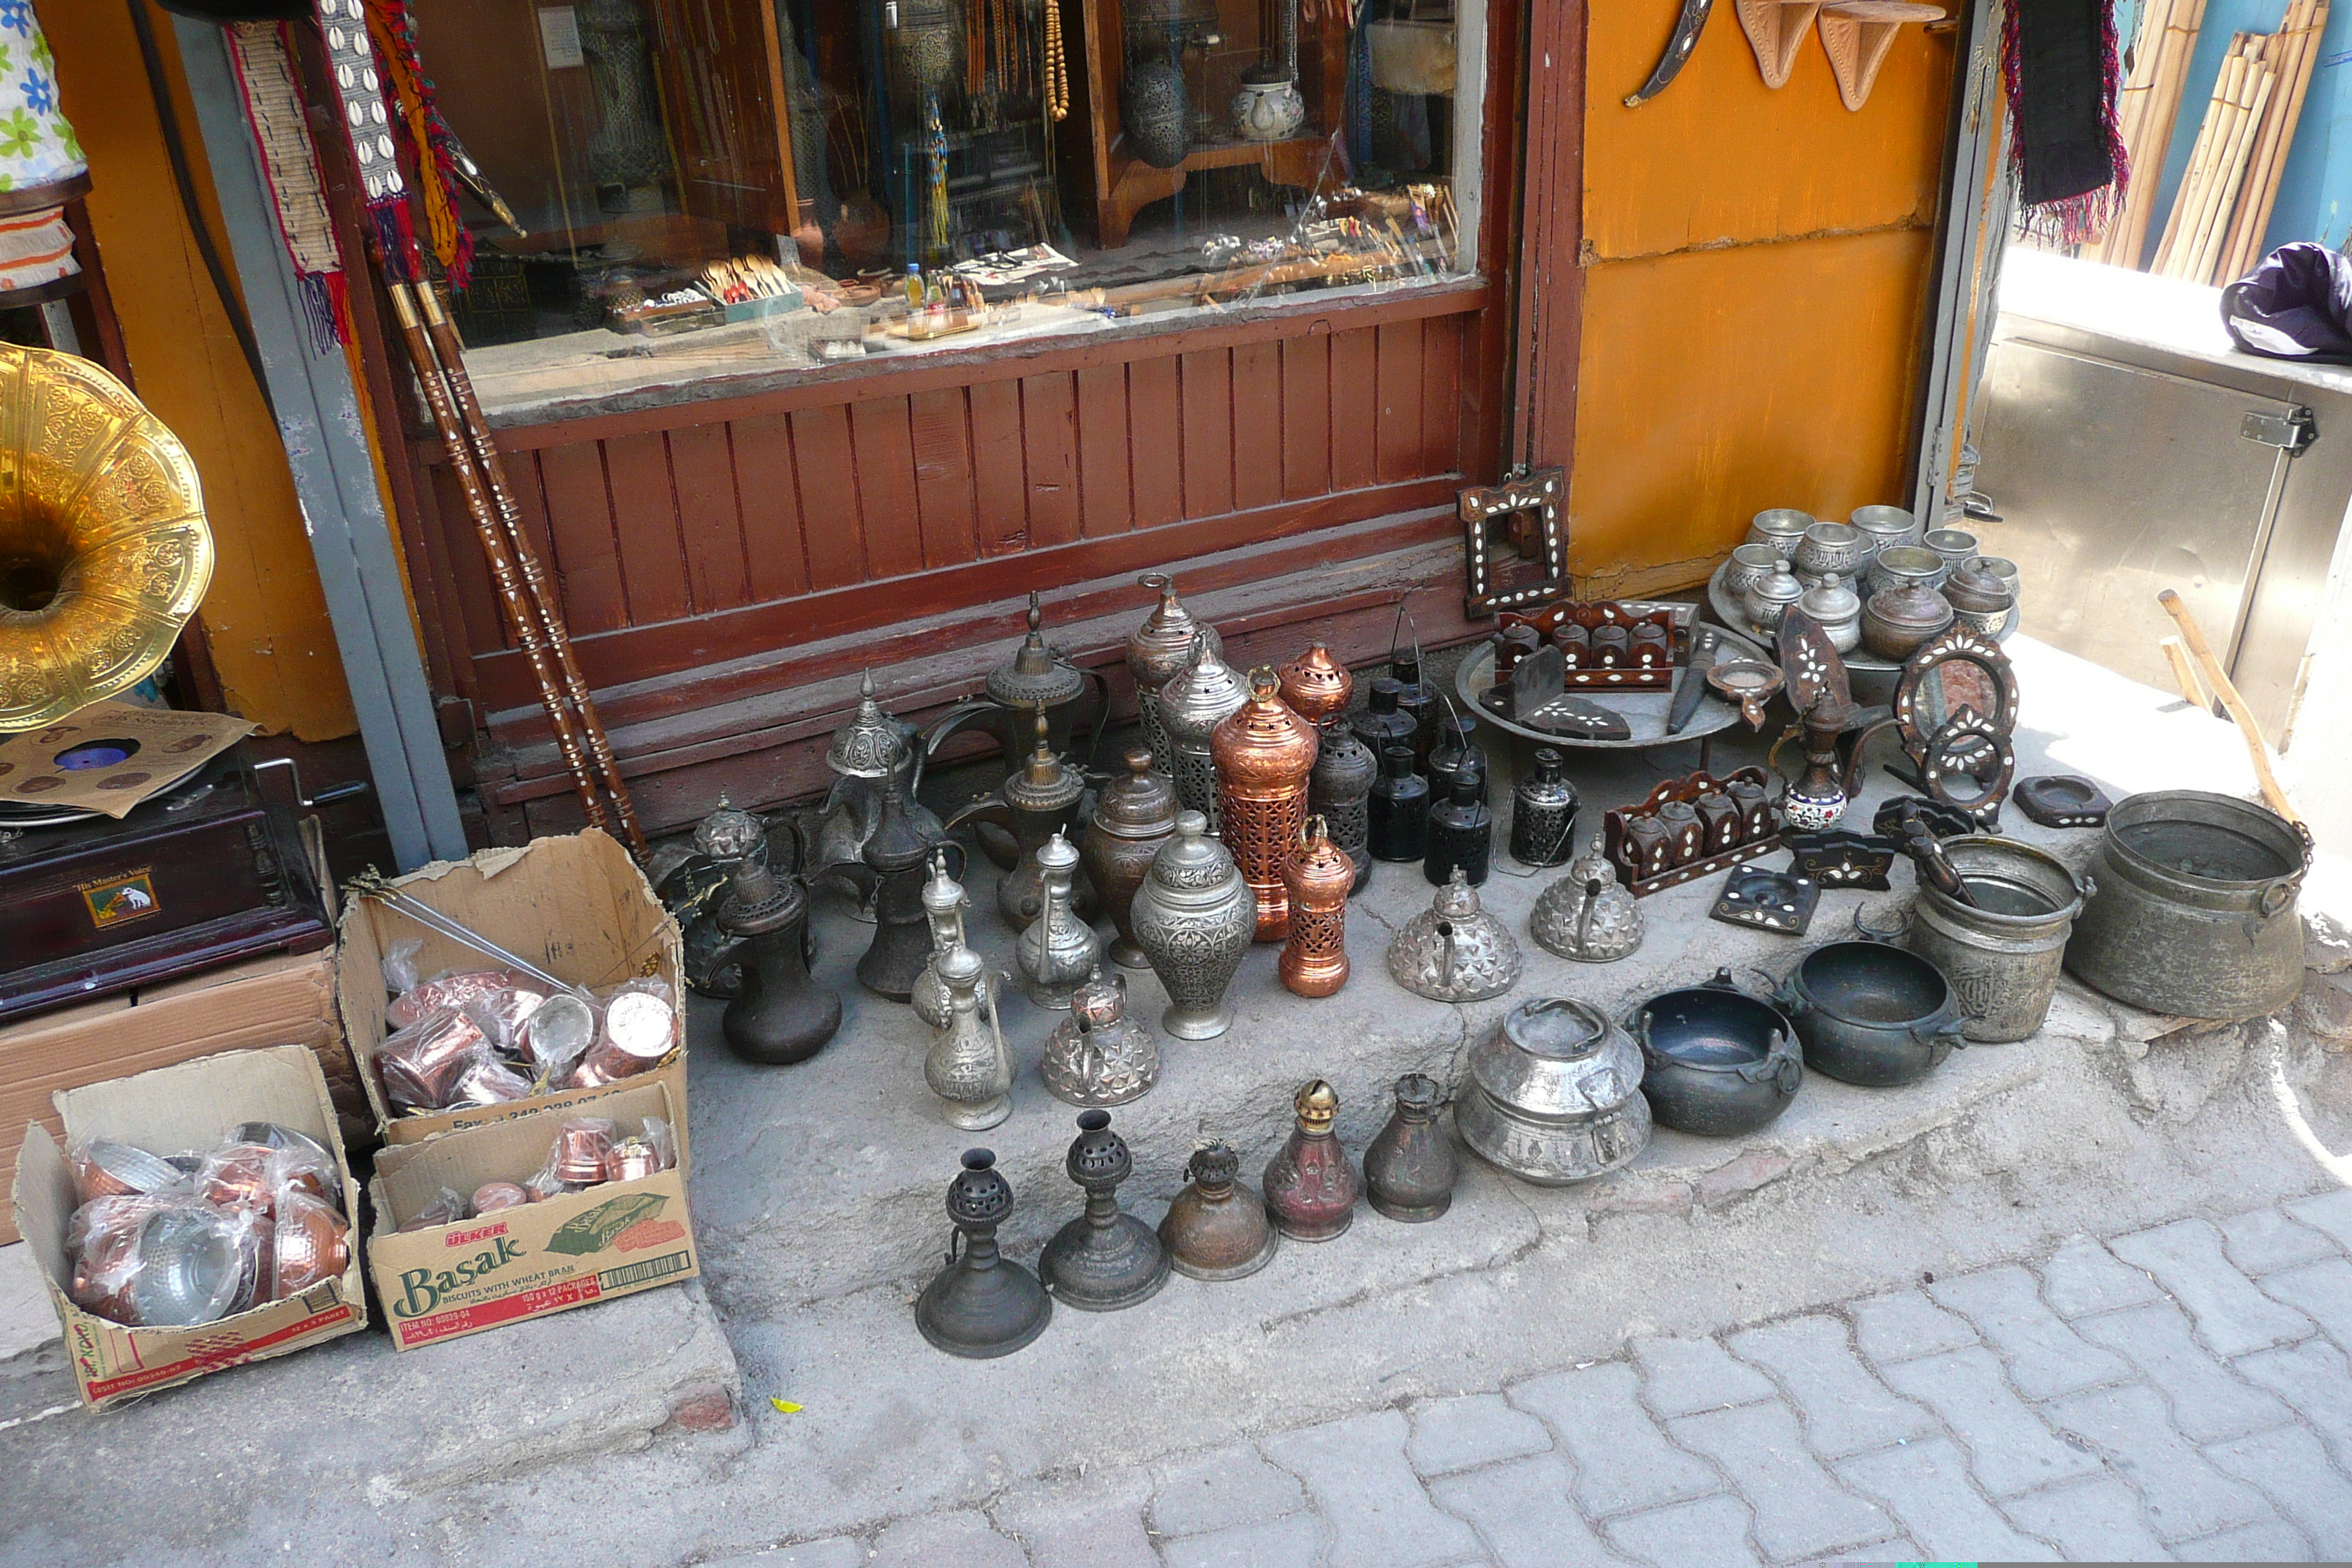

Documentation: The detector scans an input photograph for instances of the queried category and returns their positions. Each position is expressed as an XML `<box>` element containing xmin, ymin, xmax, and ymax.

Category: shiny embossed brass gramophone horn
<box><xmin>0</xmin><ymin>343</ymin><xmax>211</xmax><ymax>734</ymax></box>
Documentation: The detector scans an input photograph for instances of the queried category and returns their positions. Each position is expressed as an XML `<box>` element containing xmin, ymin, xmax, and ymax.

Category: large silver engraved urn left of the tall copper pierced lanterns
<box><xmin>1134</xmin><ymin>811</ymin><xmax>1259</xmax><ymax>1039</ymax></box>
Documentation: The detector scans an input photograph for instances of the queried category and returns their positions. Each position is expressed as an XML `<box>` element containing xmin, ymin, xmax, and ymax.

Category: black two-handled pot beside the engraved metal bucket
<box><xmin>1774</xmin><ymin>943</ymin><xmax>1967</xmax><ymax>1088</ymax></box>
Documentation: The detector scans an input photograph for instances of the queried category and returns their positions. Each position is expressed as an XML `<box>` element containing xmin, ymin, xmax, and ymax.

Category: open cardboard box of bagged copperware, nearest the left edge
<box><xmin>10</xmin><ymin>1044</ymin><xmax>367</xmax><ymax>1411</ymax></box>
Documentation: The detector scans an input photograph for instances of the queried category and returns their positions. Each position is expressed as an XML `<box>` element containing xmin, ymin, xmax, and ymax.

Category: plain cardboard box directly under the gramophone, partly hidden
<box><xmin>0</xmin><ymin>947</ymin><xmax>347</xmax><ymax>1246</ymax></box>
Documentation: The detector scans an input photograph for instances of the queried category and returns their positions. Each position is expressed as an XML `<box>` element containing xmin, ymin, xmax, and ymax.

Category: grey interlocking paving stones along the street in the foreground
<box><xmin>743</xmin><ymin>1192</ymin><xmax>2352</xmax><ymax>1568</ymax></box>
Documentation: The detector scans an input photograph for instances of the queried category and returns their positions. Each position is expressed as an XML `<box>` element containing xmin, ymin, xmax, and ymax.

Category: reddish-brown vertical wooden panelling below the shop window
<box><xmin>433</xmin><ymin>313</ymin><xmax>1477</xmax><ymax>710</ymax></box>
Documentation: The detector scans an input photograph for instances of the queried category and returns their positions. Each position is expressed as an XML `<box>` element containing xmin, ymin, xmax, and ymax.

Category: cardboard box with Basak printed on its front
<box><xmin>367</xmin><ymin>1077</ymin><xmax>704</xmax><ymax>1349</ymax></box>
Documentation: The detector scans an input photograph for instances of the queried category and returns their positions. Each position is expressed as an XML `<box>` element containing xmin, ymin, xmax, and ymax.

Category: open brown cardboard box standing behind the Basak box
<box><xmin>336</xmin><ymin>827</ymin><xmax>687</xmax><ymax>1152</ymax></box>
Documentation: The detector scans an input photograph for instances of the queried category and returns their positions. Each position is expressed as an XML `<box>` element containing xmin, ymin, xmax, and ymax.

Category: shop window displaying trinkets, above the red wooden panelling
<box><xmin>412</xmin><ymin>0</ymin><xmax>1482</xmax><ymax>414</ymax></box>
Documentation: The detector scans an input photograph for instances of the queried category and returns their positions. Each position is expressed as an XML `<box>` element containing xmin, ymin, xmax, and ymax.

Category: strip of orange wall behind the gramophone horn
<box><xmin>40</xmin><ymin>0</ymin><xmax>358</xmax><ymax>741</ymax></box>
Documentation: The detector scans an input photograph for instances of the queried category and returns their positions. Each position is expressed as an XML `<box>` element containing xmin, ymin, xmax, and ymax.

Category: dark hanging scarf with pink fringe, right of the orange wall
<box><xmin>2002</xmin><ymin>0</ymin><xmax>2131</xmax><ymax>244</ymax></box>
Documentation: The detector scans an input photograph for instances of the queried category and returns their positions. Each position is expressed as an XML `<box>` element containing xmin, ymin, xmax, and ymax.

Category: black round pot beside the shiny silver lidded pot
<box><xmin>1630</xmin><ymin>968</ymin><xmax>1804</xmax><ymax>1138</ymax></box>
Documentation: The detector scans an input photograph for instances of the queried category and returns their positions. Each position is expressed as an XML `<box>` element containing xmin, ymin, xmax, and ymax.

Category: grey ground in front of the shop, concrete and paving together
<box><xmin>0</xmin><ymin>634</ymin><xmax>2352</xmax><ymax>1568</ymax></box>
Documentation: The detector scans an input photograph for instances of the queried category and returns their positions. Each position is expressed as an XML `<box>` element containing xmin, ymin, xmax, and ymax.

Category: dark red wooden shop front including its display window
<box><xmin>336</xmin><ymin>0</ymin><xmax>1523</xmax><ymax>840</ymax></box>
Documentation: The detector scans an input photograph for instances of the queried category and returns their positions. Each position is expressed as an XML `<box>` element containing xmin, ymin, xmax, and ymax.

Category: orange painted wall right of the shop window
<box><xmin>1569</xmin><ymin>0</ymin><xmax>1954</xmax><ymax>592</ymax></box>
